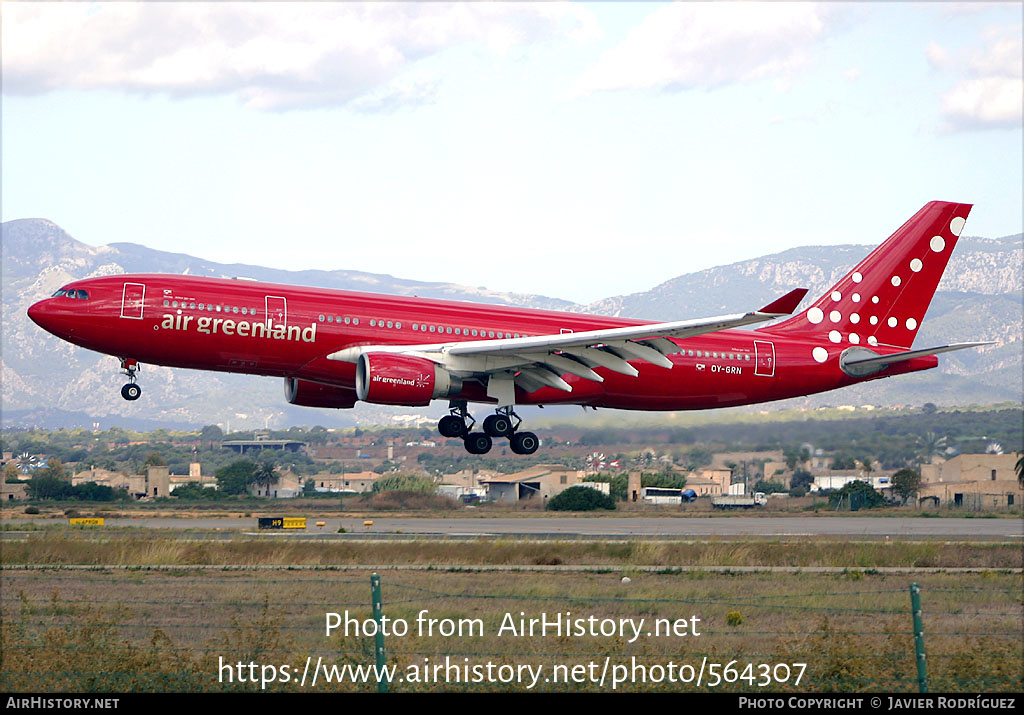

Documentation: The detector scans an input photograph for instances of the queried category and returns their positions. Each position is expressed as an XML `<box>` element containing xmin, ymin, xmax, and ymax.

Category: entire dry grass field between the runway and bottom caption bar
<box><xmin>0</xmin><ymin>532</ymin><xmax>1024</xmax><ymax>692</ymax></box>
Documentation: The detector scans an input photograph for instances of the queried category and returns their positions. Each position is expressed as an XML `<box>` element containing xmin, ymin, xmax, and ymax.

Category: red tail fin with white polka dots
<box><xmin>763</xmin><ymin>201</ymin><xmax>971</xmax><ymax>348</ymax></box>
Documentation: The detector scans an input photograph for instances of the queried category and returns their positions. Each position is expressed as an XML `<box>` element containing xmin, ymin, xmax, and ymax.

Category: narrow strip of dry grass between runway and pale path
<box><xmin>3</xmin><ymin>532</ymin><xmax>1024</xmax><ymax>570</ymax></box>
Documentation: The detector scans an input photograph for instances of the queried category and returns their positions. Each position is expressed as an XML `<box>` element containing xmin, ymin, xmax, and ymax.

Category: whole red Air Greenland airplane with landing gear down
<box><xmin>29</xmin><ymin>202</ymin><xmax>985</xmax><ymax>454</ymax></box>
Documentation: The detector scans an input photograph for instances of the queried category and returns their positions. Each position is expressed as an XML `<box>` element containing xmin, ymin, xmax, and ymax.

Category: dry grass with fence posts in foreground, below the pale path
<box><xmin>0</xmin><ymin>571</ymin><xmax>1024</xmax><ymax>692</ymax></box>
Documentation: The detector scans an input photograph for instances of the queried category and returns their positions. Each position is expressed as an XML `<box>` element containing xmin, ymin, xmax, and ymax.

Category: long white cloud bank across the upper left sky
<box><xmin>3</xmin><ymin>2</ymin><xmax>597</xmax><ymax>110</ymax></box>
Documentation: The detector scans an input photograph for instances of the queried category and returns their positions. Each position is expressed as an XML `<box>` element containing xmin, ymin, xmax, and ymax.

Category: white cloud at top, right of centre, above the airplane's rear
<box><xmin>572</xmin><ymin>2</ymin><xmax>825</xmax><ymax>96</ymax></box>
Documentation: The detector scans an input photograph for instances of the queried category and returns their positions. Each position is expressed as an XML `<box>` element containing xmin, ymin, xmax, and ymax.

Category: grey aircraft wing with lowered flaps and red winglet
<box><xmin>328</xmin><ymin>288</ymin><xmax>807</xmax><ymax>405</ymax></box>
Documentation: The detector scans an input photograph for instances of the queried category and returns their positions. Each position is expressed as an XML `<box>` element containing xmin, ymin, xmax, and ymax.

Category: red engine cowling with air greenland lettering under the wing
<box><xmin>355</xmin><ymin>352</ymin><xmax>462</xmax><ymax>407</ymax></box>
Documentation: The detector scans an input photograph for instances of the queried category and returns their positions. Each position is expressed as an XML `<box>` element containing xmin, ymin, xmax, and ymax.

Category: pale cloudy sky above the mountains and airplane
<box><xmin>0</xmin><ymin>2</ymin><xmax>1024</xmax><ymax>303</ymax></box>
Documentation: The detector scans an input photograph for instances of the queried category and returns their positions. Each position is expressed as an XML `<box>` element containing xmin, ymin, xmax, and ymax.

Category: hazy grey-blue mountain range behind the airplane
<box><xmin>0</xmin><ymin>218</ymin><xmax>1024</xmax><ymax>429</ymax></box>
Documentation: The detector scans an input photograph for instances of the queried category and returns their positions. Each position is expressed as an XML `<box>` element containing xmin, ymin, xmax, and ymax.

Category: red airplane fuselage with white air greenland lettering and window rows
<box><xmin>30</xmin><ymin>274</ymin><xmax>938</xmax><ymax>410</ymax></box>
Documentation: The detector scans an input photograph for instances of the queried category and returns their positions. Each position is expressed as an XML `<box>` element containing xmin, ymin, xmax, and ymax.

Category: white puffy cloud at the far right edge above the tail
<box><xmin>929</xmin><ymin>25</ymin><xmax>1024</xmax><ymax>130</ymax></box>
